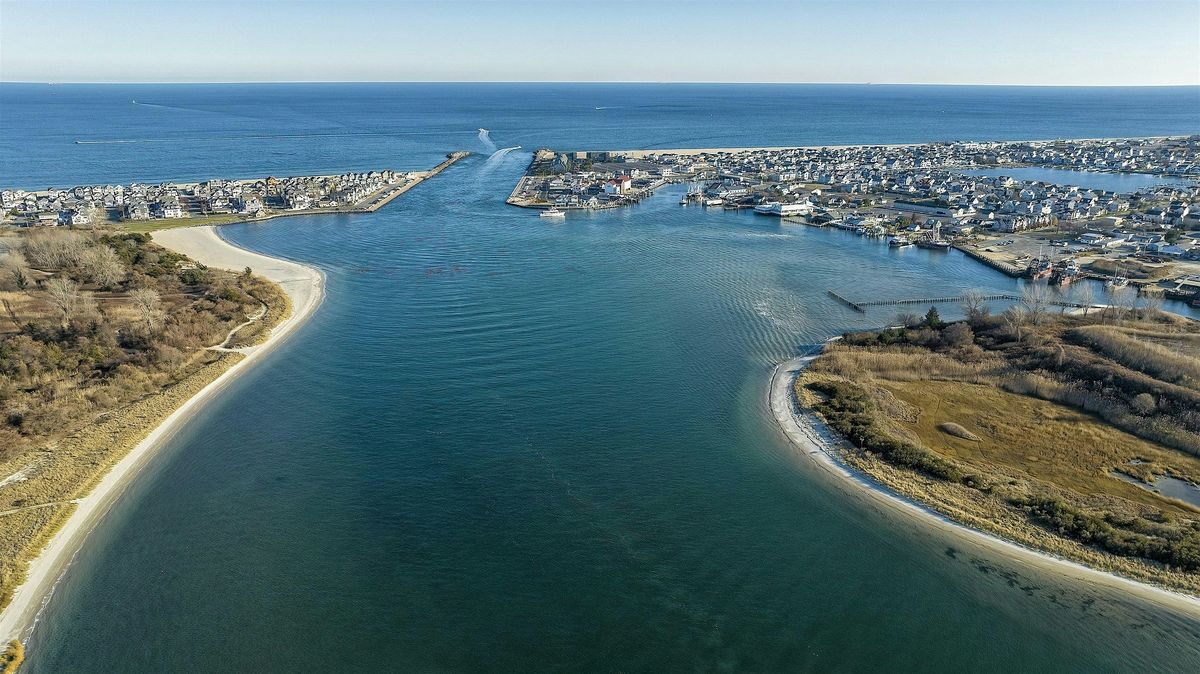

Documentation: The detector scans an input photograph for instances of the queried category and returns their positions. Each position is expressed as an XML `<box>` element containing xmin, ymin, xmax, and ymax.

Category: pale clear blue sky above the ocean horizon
<box><xmin>0</xmin><ymin>0</ymin><xmax>1200</xmax><ymax>85</ymax></box>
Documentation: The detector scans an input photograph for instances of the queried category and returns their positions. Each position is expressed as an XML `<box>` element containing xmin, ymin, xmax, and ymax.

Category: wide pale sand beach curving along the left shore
<box><xmin>0</xmin><ymin>225</ymin><xmax>325</xmax><ymax>642</ymax></box>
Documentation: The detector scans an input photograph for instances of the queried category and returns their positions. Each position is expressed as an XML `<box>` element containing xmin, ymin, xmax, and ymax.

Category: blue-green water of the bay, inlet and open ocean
<box><xmin>0</xmin><ymin>84</ymin><xmax>1200</xmax><ymax>673</ymax></box>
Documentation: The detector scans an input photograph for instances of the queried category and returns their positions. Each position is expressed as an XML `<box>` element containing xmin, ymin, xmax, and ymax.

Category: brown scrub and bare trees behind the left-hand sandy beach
<box><xmin>0</xmin><ymin>230</ymin><xmax>290</xmax><ymax>607</ymax></box>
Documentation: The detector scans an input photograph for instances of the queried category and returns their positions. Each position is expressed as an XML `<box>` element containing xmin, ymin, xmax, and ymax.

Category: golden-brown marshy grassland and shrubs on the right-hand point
<box><xmin>796</xmin><ymin>303</ymin><xmax>1200</xmax><ymax>592</ymax></box>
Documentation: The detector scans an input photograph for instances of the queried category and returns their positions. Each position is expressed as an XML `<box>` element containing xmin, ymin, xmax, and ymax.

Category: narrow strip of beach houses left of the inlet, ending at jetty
<box><xmin>0</xmin><ymin>170</ymin><xmax>426</xmax><ymax>227</ymax></box>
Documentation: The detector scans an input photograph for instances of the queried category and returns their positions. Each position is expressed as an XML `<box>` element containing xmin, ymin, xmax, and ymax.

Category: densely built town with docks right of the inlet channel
<box><xmin>509</xmin><ymin>136</ymin><xmax>1200</xmax><ymax>300</ymax></box>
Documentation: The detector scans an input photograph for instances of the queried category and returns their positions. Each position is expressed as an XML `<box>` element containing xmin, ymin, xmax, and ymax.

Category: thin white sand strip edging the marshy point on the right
<box><xmin>768</xmin><ymin>355</ymin><xmax>1200</xmax><ymax>618</ymax></box>
